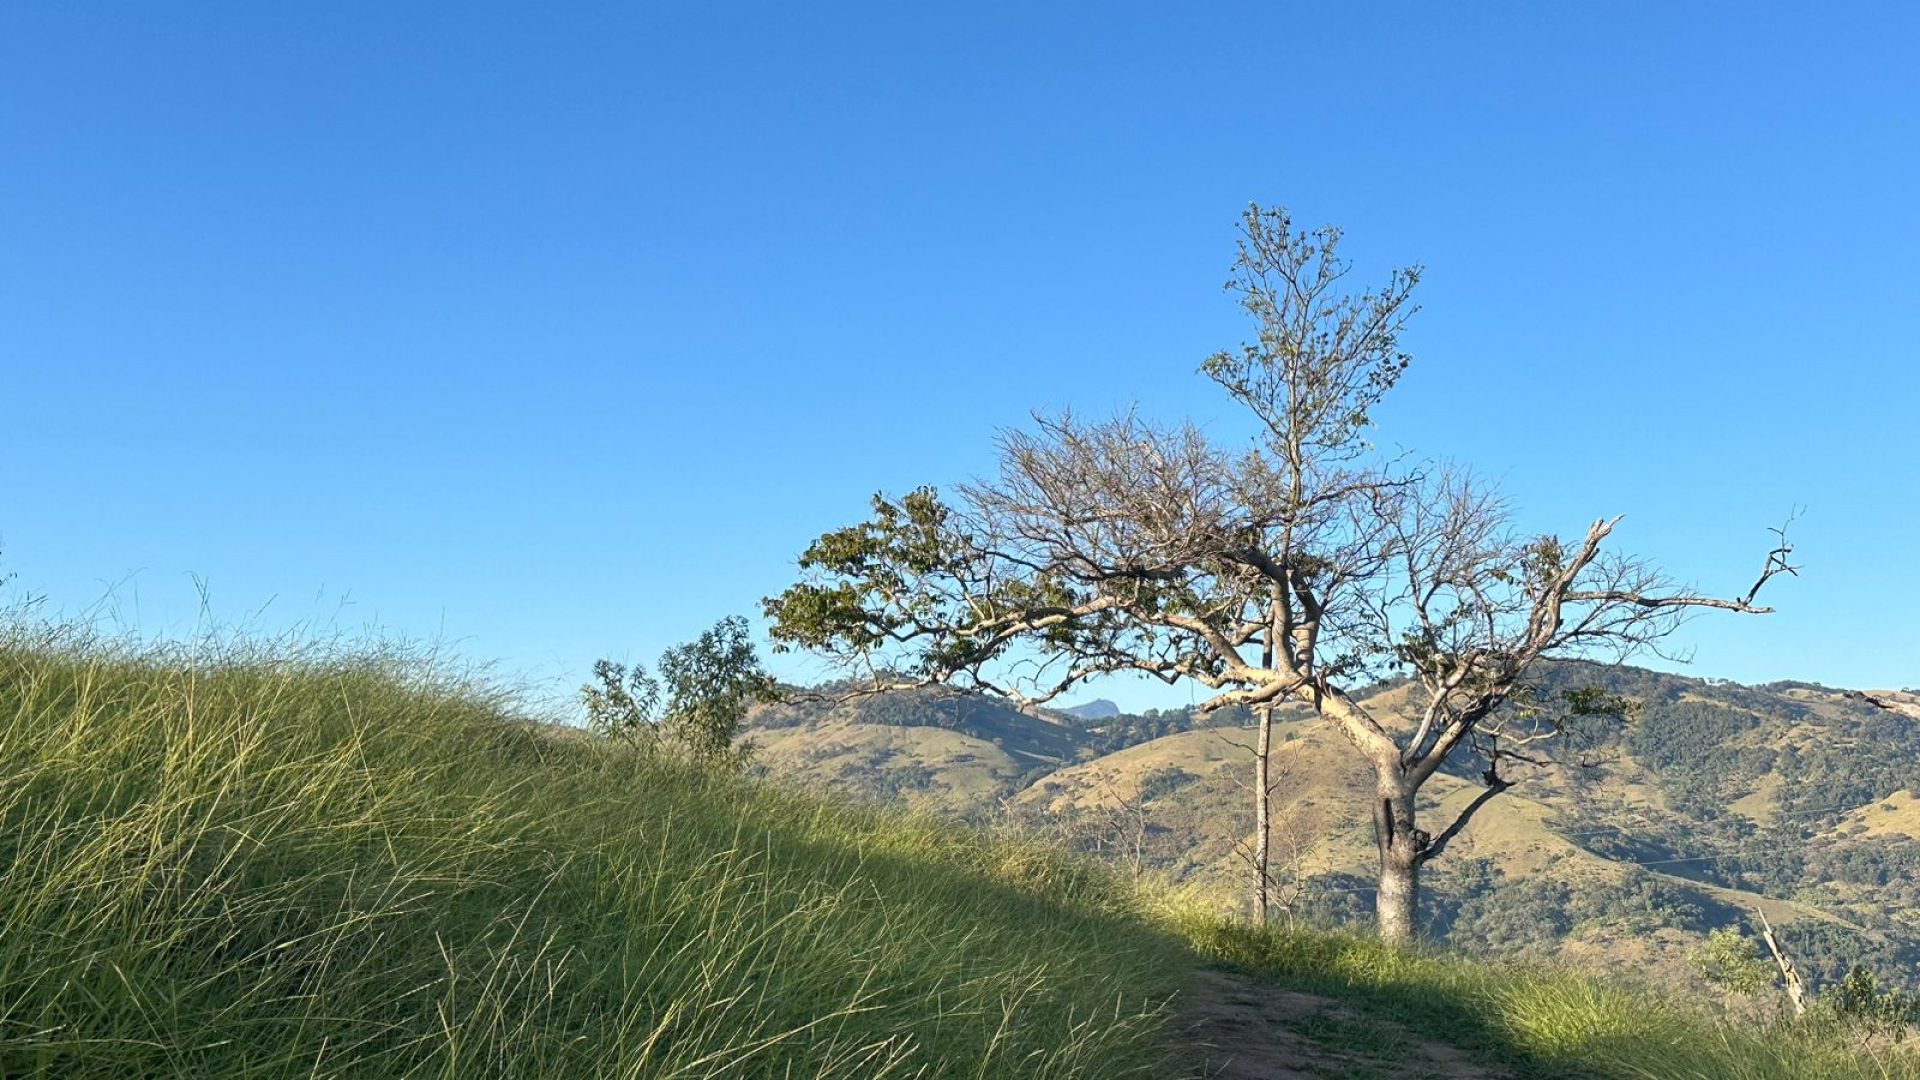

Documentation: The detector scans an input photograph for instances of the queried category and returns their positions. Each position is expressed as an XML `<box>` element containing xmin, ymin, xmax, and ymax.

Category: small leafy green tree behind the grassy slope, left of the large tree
<box><xmin>580</xmin><ymin>615</ymin><xmax>776</xmax><ymax>769</ymax></box>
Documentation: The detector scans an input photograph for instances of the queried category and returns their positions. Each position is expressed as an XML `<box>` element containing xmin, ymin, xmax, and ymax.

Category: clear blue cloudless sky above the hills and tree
<box><xmin>0</xmin><ymin>0</ymin><xmax>1920</xmax><ymax>707</ymax></box>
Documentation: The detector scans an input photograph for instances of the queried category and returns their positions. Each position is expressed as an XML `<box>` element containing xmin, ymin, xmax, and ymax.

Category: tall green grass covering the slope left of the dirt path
<box><xmin>0</xmin><ymin>628</ymin><xmax>1190</xmax><ymax>1078</ymax></box>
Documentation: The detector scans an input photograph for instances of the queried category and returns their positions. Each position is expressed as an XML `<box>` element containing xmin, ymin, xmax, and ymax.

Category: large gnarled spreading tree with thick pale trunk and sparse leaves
<box><xmin>766</xmin><ymin>206</ymin><xmax>1793</xmax><ymax>942</ymax></box>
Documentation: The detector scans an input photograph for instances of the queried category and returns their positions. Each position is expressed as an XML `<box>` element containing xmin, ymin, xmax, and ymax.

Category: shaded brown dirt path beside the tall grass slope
<box><xmin>1185</xmin><ymin>970</ymin><xmax>1509</xmax><ymax>1080</ymax></box>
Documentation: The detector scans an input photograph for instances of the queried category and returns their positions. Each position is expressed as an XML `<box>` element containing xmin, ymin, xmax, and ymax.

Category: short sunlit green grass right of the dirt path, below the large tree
<box><xmin>1185</xmin><ymin>917</ymin><xmax>1920</xmax><ymax>1080</ymax></box>
